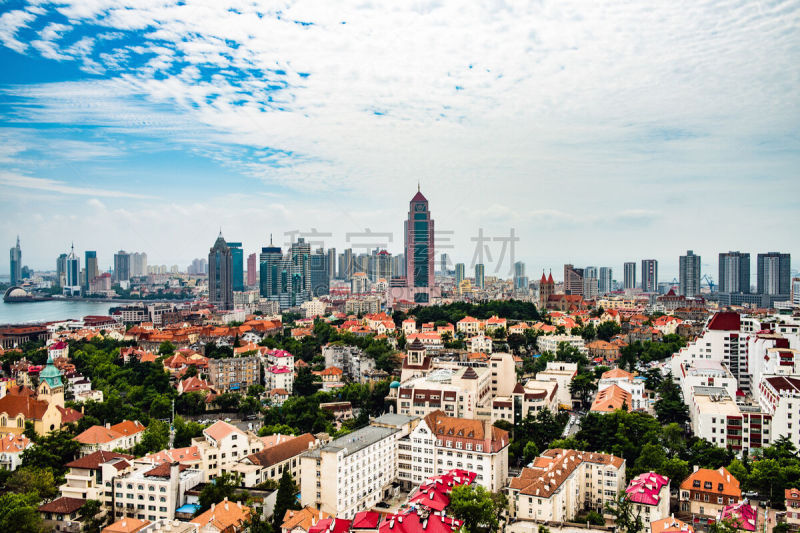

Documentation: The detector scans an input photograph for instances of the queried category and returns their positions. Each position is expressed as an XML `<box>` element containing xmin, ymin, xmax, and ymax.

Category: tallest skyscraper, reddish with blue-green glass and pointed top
<box><xmin>405</xmin><ymin>188</ymin><xmax>434</xmax><ymax>303</ymax></box>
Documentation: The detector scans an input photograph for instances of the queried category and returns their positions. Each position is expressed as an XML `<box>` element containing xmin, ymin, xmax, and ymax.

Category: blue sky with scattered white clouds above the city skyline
<box><xmin>0</xmin><ymin>0</ymin><xmax>800</xmax><ymax>280</ymax></box>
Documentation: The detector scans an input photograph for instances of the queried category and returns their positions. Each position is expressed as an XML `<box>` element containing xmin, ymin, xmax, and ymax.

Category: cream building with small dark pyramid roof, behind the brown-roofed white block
<box><xmin>397</xmin><ymin>366</ymin><xmax>492</xmax><ymax>419</ymax></box>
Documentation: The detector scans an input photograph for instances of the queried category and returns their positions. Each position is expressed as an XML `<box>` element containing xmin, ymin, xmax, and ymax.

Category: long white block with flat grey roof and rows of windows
<box><xmin>300</xmin><ymin>425</ymin><xmax>403</xmax><ymax>518</ymax></box>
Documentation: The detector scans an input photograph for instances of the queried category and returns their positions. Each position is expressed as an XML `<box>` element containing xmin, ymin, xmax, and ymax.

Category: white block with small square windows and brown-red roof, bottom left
<box><xmin>113</xmin><ymin>463</ymin><xmax>203</xmax><ymax>522</ymax></box>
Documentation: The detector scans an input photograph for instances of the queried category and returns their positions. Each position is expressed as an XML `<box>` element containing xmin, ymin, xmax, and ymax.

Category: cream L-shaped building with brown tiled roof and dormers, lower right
<box><xmin>508</xmin><ymin>449</ymin><xmax>625</xmax><ymax>522</ymax></box>
